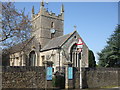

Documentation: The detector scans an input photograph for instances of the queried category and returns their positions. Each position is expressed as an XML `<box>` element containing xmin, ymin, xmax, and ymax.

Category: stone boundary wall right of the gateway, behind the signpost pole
<box><xmin>73</xmin><ymin>68</ymin><xmax>120</xmax><ymax>88</ymax></box>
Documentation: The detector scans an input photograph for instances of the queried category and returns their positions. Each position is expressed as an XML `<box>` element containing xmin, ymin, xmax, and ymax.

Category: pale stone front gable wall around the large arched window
<box><xmin>62</xmin><ymin>32</ymin><xmax>88</xmax><ymax>67</ymax></box>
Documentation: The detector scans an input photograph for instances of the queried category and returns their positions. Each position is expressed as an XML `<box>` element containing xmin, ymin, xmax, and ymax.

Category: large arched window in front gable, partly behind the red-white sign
<box><xmin>70</xmin><ymin>44</ymin><xmax>80</xmax><ymax>67</ymax></box>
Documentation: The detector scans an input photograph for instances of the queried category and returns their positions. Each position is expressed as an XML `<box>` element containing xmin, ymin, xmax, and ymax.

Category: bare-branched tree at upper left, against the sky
<box><xmin>0</xmin><ymin>2</ymin><xmax>31</xmax><ymax>47</ymax></box>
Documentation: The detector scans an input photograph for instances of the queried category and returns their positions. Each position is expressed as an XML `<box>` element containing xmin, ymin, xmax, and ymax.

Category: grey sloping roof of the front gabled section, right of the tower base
<box><xmin>41</xmin><ymin>31</ymin><xmax>76</xmax><ymax>52</ymax></box>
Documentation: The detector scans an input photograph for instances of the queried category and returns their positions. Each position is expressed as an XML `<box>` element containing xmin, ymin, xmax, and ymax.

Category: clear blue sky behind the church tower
<box><xmin>15</xmin><ymin>2</ymin><xmax>118</xmax><ymax>61</ymax></box>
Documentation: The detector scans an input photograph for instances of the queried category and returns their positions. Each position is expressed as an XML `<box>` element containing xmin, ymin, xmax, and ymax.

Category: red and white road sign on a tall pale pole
<box><xmin>77</xmin><ymin>39</ymin><xmax>84</xmax><ymax>89</ymax></box>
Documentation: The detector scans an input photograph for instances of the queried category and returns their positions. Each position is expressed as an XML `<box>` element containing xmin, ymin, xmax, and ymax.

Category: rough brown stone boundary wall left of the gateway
<box><xmin>2</xmin><ymin>66</ymin><xmax>46</xmax><ymax>89</ymax></box>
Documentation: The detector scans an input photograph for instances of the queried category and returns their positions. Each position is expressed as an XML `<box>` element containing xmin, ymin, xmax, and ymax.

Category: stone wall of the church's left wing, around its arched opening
<box><xmin>9</xmin><ymin>38</ymin><xmax>40</xmax><ymax>66</ymax></box>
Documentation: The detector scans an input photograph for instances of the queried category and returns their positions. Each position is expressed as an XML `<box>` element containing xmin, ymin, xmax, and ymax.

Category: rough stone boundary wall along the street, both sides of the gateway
<box><xmin>2</xmin><ymin>66</ymin><xmax>120</xmax><ymax>90</ymax></box>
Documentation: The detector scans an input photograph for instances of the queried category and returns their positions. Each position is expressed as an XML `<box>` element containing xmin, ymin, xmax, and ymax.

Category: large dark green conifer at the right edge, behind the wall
<box><xmin>98</xmin><ymin>25</ymin><xmax>120</xmax><ymax>67</ymax></box>
